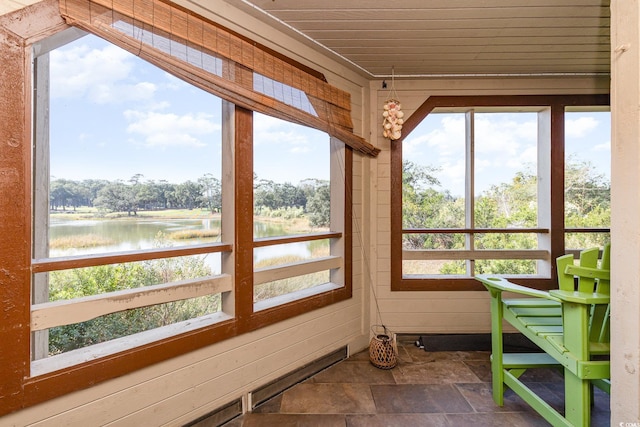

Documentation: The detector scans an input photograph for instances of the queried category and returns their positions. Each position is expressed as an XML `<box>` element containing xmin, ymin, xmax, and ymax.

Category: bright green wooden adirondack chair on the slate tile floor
<box><xmin>476</xmin><ymin>244</ymin><xmax>611</xmax><ymax>427</ymax></box>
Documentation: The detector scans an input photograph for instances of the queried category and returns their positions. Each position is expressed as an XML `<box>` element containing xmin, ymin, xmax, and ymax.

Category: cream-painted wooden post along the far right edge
<box><xmin>611</xmin><ymin>0</ymin><xmax>640</xmax><ymax>426</ymax></box>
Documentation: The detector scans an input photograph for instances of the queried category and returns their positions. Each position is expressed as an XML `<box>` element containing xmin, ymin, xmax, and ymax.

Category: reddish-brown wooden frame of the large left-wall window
<box><xmin>0</xmin><ymin>0</ymin><xmax>353</xmax><ymax>416</ymax></box>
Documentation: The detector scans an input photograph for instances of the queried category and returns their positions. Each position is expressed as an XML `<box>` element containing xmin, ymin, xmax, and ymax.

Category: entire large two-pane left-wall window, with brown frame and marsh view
<box><xmin>0</xmin><ymin>3</ymin><xmax>358</xmax><ymax>414</ymax></box>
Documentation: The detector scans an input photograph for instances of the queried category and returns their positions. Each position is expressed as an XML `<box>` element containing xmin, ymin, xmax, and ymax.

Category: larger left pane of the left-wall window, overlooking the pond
<box><xmin>32</xmin><ymin>31</ymin><xmax>231</xmax><ymax>374</ymax></box>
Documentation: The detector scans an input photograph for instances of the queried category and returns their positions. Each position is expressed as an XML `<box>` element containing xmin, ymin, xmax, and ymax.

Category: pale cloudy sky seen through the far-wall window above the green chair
<box><xmin>403</xmin><ymin>112</ymin><xmax>611</xmax><ymax>195</ymax></box>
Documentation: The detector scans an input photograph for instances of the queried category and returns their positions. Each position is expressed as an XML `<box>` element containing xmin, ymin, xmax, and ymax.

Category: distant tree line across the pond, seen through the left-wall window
<box><xmin>49</xmin><ymin>174</ymin><xmax>330</xmax><ymax>227</ymax></box>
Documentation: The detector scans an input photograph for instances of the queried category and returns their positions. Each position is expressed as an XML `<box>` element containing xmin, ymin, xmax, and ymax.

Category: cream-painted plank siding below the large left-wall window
<box><xmin>0</xmin><ymin>306</ymin><xmax>361</xmax><ymax>426</ymax></box>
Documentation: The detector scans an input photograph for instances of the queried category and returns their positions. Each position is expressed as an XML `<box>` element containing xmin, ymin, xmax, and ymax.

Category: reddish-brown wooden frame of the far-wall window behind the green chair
<box><xmin>391</xmin><ymin>94</ymin><xmax>609</xmax><ymax>291</ymax></box>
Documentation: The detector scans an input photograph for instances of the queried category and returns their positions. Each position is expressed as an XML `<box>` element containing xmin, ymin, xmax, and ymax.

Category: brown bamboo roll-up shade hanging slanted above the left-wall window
<box><xmin>60</xmin><ymin>0</ymin><xmax>380</xmax><ymax>156</ymax></box>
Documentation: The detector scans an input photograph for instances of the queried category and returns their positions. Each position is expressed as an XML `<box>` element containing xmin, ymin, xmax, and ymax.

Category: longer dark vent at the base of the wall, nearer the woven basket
<box><xmin>251</xmin><ymin>346</ymin><xmax>347</xmax><ymax>409</ymax></box>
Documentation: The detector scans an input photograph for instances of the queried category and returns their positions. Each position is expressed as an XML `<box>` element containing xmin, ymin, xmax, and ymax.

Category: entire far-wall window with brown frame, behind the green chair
<box><xmin>392</xmin><ymin>96</ymin><xmax>610</xmax><ymax>290</ymax></box>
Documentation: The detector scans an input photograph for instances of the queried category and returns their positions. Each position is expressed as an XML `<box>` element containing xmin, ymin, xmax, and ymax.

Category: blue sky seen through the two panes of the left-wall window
<box><xmin>50</xmin><ymin>36</ymin><xmax>329</xmax><ymax>184</ymax></box>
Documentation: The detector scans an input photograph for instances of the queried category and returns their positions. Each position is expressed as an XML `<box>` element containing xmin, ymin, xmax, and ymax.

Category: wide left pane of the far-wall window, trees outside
<box><xmin>402</xmin><ymin>109</ymin><xmax>538</xmax><ymax>277</ymax></box>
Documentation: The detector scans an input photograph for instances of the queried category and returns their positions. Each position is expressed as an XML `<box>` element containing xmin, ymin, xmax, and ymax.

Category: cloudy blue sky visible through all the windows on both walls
<box><xmin>50</xmin><ymin>36</ymin><xmax>610</xmax><ymax>194</ymax></box>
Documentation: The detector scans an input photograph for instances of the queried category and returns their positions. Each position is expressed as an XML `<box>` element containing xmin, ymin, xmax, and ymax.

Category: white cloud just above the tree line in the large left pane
<box><xmin>124</xmin><ymin>110</ymin><xmax>220</xmax><ymax>147</ymax></box>
